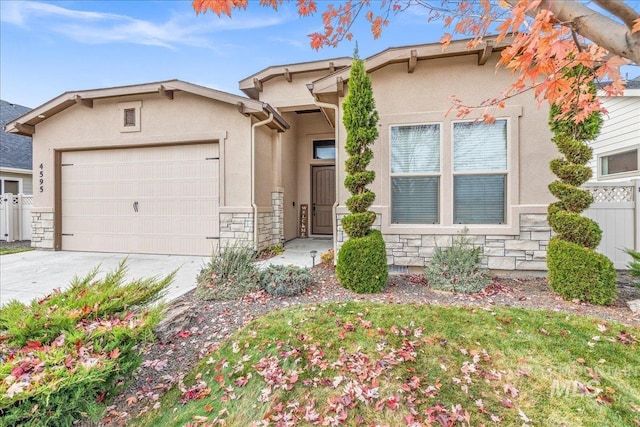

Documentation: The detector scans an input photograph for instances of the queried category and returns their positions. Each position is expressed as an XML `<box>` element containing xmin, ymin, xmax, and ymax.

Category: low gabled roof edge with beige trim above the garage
<box><xmin>4</xmin><ymin>80</ymin><xmax>289</xmax><ymax>135</ymax></box>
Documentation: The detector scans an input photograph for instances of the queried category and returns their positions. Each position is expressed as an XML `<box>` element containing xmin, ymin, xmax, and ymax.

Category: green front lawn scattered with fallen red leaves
<box><xmin>134</xmin><ymin>302</ymin><xmax>640</xmax><ymax>427</ymax></box>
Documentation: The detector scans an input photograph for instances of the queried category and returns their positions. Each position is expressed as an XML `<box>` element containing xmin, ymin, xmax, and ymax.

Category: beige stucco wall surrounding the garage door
<box><xmin>33</xmin><ymin>92</ymin><xmax>251</xmax><ymax>209</ymax></box>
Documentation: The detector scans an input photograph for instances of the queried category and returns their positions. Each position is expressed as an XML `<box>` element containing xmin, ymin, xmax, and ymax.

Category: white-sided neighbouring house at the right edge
<box><xmin>590</xmin><ymin>77</ymin><xmax>640</xmax><ymax>182</ymax></box>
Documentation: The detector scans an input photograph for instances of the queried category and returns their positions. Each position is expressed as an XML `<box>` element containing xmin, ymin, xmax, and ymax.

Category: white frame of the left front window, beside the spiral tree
<box><xmin>388</xmin><ymin>121</ymin><xmax>444</xmax><ymax>227</ymax></box>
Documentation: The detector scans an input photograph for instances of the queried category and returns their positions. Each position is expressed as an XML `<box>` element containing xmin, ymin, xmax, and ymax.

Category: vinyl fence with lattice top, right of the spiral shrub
<box><xmin>583</xmin><ymin>180</ymin><xmax>640</xmax><ymax>269</ymax></box>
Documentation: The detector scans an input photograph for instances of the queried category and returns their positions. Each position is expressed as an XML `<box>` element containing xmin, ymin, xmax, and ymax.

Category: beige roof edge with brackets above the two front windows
<box><xmin>307</xmin><ymin>37</ymin><xmax>513</xmax><ymax>95</ymax></box>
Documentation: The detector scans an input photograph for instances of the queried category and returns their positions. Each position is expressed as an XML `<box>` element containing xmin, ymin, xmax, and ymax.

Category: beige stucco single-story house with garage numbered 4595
<box><xmin>7</xmin><ymin>36</ymin><xmax>557</xmax><ymax>270</ymax></box>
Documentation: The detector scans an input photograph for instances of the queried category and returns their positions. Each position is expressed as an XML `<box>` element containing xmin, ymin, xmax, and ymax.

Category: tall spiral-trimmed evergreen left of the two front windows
<box><xmin>336</xmin><ymin>48</ymin><xmax>388</xmax><ymax>293</ymax></box>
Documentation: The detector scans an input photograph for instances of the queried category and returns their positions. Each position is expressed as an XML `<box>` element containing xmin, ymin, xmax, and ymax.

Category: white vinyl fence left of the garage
<box><xmin>0</xmin><ymin>193</ymin><xmax>33</xmax><ymax>242</ymax></box>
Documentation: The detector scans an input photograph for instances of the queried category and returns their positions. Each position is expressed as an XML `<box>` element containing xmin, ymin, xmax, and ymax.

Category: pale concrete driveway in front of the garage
<box><xmin>0</xmin><ymin>251</ymin><xmax>208</xmax><ymax>305</ymax></box>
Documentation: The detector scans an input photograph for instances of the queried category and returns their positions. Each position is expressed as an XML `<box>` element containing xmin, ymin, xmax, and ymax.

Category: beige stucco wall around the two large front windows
<box><xmin>339</xmin><ymin>54</ymin><xmax>556</xmax><ymax>233</ymax></box>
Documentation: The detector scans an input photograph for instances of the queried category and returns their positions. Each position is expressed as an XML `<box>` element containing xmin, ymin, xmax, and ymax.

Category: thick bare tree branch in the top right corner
<box><xmin>506</xmin><ymin>0</ymin><xmax>640</xmax><ymax>64</ymax></box>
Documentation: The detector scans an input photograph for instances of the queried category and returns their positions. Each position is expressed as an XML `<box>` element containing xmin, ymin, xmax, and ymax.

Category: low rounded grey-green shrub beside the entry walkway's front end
<box><xmin>260</xmin><ymin>265</ymin><xmax>313</xmax><ymax>297</ymax></box>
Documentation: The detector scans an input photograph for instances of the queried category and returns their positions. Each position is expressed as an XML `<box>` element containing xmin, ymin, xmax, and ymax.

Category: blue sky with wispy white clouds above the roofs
<box><xmin>0</xmin><ymin>0</ymin><xmax>442</xmax><ymax>108</ymax></box>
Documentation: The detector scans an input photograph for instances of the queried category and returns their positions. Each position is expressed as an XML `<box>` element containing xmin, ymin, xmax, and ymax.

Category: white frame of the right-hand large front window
<box><xmin>449</xmin><ymin>117</ymin><xmax>511</xmax><ymax>226</ymax></box>
